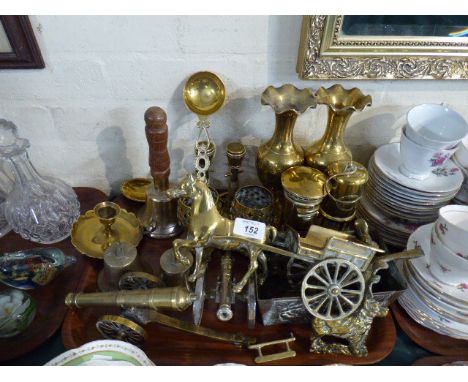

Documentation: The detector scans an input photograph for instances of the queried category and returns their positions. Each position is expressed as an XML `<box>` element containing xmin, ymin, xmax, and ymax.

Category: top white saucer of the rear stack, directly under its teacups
<box><xmin>374</xmin><ymin>142</ymin><xmax>463</xmax><ymax>193</ymax></box>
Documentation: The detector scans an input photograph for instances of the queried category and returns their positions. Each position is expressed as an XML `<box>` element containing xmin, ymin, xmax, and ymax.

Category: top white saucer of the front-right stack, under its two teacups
<box><xmin>406</xmin><ymin>223</ymin><xmax>468</xmax><ymax>309</ymax></box>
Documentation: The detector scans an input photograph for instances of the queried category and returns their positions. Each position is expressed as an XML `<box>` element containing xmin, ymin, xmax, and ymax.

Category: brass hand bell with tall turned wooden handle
<box><xmin>139</xmin><ymin>107</ymin><xmax>182</xmax><ymax>239</ymax></box>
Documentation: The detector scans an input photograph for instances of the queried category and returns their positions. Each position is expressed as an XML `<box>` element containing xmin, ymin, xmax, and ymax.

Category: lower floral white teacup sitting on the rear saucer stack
<box><xmin>399</xmin><ymin>128</ymin><xmax>455</xmax><ymax>180</ymax></box>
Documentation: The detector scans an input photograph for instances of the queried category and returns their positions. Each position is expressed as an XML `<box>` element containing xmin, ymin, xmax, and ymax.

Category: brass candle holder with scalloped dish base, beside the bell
<box><xmin>71</xmin><ymin>202</ymin><xmax>143</xmax><ymax>259</ymax></box>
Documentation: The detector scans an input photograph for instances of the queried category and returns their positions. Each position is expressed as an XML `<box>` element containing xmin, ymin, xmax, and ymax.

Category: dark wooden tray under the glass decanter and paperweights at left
<box><xmin>0</xmin><ymin>187</ymin><xmax>107</xmax><ymax>362</ymax></box>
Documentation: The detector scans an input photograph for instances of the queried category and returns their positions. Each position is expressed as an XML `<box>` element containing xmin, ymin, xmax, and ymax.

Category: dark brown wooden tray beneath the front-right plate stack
<box><xmin>391</xmin><ymin>302</ymin><xmax>468</xmax><ymax>356</ymax></box>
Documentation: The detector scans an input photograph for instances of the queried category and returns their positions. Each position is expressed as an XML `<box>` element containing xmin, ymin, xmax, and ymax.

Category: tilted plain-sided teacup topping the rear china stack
<box><xmin>406</xmin><ymin>103</ymin><xmax>468</xmax><ymax>150</ymax></box>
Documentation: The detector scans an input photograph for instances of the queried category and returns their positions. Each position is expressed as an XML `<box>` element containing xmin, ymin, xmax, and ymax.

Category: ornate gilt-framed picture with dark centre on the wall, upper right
<box><xmin>297</xmin><ymin>15</ymin><xmax>468</xmax><ymax>80</ymax></box>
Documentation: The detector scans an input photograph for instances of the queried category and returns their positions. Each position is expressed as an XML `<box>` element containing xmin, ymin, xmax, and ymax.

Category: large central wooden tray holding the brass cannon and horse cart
<box><xmin>62</xmin><ymin>198</ymin><xmax>396</xmax><ymax>365</ymax></box>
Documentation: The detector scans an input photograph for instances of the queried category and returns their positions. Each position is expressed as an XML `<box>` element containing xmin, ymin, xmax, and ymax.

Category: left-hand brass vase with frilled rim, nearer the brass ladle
<box><xmin>256</xmin><ymin>84</ymin><xmax>317</xmax><ymax>191</ymax></box>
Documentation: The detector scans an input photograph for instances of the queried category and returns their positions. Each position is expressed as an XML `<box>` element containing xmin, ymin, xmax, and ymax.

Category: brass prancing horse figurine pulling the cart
<box><xmin>166</xmin><ymin>174</ymin><xmax>277</xmax><ymax>293</ymax></box>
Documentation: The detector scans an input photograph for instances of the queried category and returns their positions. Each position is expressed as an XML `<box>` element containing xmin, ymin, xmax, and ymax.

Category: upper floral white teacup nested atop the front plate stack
<box><xmin>434</xmin><ymin>204</ymin><xmax>468</xmax><ymax>262</ymax></box>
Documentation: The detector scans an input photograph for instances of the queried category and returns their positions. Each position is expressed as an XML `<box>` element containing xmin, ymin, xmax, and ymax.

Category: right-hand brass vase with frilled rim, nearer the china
<box><xmin>305</xmin><ymin>84</ymin><xmax>372</xmax><ymax>171</ymax></box>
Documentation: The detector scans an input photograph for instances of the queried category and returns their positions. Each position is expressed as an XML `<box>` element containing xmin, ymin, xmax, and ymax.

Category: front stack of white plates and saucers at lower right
<box><xmin>398</xmin><ymin>223</ymin><xmax>468</xmax><ymax>340</ymax></box>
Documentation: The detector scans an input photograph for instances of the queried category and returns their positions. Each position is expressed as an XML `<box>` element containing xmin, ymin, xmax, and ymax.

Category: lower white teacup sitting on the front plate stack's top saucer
<box><xmin>429</xmin><ymin>225</ymin><xmax>468</xmax><ymax>286</ymax></box>
